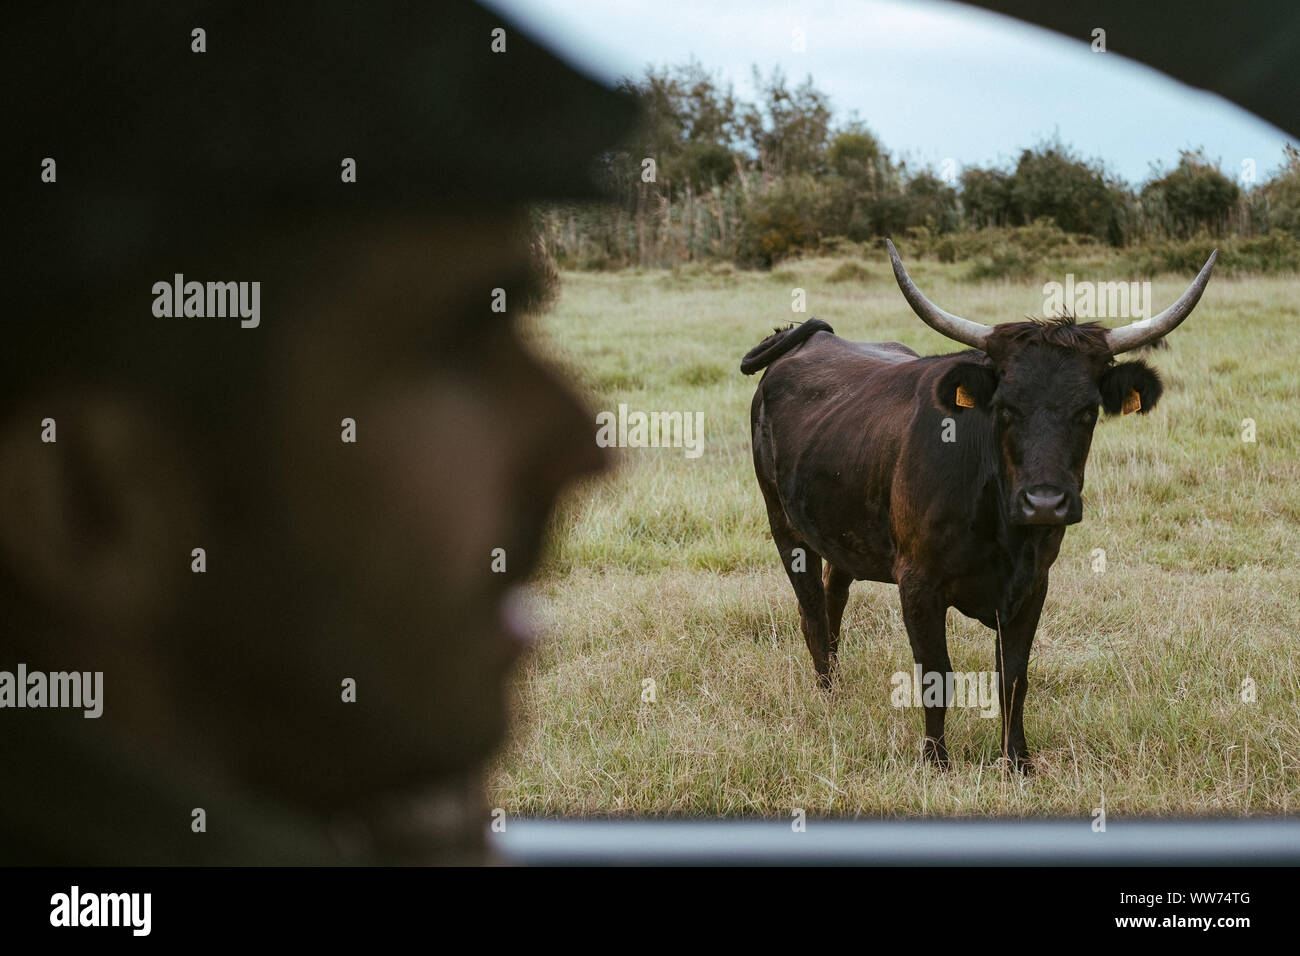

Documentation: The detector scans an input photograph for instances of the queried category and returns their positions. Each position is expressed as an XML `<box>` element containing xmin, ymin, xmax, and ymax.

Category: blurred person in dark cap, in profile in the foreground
<box><xmin>0</xmin><ymin>3</ymin><xmax>633</xmax><ymax>865</ymax></box>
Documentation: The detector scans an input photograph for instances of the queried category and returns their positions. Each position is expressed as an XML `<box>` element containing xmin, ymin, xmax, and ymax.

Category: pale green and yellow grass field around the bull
<box><xmin>489</xmin><ymin>255</ymin><xmax>1300</xmax><ymax>818</ymax></box>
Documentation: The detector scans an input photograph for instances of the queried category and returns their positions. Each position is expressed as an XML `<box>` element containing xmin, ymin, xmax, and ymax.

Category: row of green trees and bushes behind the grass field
<box><xmin>538</xmin><ymin>61</ymin><xmax>1300</xmax><ymax>269</ymax></box>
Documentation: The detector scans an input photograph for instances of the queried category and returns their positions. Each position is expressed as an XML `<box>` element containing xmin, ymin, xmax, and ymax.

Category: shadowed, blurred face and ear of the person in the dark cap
<box><xmin>0</xmin><ymin>210</ymin><xmax>605</xmax><ymax>812</ymax></box>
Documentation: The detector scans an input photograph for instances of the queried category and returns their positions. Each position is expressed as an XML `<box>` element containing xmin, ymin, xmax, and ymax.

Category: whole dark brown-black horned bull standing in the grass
<box><xmin>741</xmin><ymin>243</ymin><xmax>1214</xmax><ymax>769</ymax></box>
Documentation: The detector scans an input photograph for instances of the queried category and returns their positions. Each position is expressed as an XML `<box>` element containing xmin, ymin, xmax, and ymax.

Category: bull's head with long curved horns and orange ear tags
<box><xmin>885</xmin><ymin>241</ymin><xmax>1218</xmax><ymax>524</ymax></box>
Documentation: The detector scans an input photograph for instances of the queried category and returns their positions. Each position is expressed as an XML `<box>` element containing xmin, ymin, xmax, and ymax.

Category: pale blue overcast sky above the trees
<box><xmin>489</xmin><ymin>0</ymin><xmax>1287</xmax><ymax>183</ymax></box>
